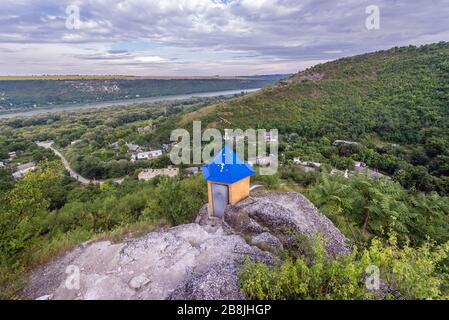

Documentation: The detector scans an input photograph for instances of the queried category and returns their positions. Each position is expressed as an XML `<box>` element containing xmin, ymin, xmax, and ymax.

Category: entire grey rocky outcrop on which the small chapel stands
<box><xmin>23</xmin><ymin>193</ymin><xmax>349</xmax><ymax>300</ymax></box>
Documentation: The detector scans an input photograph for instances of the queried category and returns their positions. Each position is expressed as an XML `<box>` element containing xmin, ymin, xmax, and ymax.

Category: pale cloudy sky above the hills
<box><xmin>0</xmin><ymin>0</ymin><xmax>449</xmax><ymax>76</ymax></box>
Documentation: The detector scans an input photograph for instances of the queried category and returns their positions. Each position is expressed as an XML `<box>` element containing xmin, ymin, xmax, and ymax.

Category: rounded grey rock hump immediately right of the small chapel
<box><xmin>225</xmin><ymin>192</ymin><xmax>350</xmax><ymax>257</ymax></box>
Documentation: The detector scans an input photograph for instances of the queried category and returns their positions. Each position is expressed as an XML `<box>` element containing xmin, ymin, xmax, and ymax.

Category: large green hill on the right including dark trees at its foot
<box><xmin>181</xmin><ymin>42</ymin><xmax>449</xmax><ymax>193</ymax></box>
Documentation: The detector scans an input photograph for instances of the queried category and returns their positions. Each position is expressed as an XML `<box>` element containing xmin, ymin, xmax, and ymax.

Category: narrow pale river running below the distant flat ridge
<box><xmin>0</xmin><ymin>88</ymin><xmax>260</xmax><ymax>119</ymax></box>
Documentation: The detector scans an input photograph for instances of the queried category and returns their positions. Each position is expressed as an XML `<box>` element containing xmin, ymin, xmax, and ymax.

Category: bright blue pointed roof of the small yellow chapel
<box><xmin>201</xmin><ymin>145</ymin><xmax>256</xmax><ymax>184</ymax></box>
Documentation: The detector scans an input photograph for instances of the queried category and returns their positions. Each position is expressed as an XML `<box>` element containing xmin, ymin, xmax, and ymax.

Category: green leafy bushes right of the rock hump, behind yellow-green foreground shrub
<box><xmin>307</xmin><ymin>173</ymin><xmax>449</xmax><ymax>245</ymax></box>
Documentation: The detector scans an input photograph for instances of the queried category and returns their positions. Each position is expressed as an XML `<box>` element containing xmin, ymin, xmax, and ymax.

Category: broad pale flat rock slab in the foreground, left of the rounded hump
<box><xmin>24</xmin><ymin>223</ymin><xmax>274</xmax><ymax>300</ymax></box>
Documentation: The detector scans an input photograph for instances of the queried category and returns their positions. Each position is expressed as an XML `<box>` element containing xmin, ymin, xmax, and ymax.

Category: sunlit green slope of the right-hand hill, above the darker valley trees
<box><xmin>180</xmin><ymin>43</ymin><xmax>449</xmax><ymax>138</ymax></box>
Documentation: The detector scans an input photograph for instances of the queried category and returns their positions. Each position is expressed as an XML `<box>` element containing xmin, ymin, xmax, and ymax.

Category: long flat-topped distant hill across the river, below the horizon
<box><xmin>0</xmin><ymin>75</ymin><xmax>289</xmax><ymax>112</ymax></box>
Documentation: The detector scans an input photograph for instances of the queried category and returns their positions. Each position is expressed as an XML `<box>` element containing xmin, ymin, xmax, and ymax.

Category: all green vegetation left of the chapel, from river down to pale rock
<box><xmin>0</xmin><ymin>97</ymin><xmax>217</xmax><ymax>298</ymax></box>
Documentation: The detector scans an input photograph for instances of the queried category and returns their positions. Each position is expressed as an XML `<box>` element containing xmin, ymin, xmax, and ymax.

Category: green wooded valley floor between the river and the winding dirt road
<box><xmin>0</xmin><ymin>97</ymin><xmax>228</xmax><ymax>181</ymax></box>
